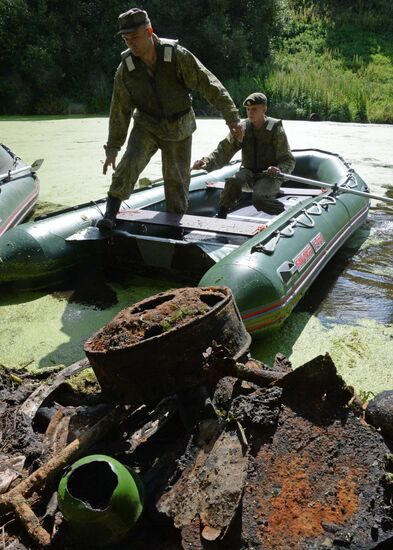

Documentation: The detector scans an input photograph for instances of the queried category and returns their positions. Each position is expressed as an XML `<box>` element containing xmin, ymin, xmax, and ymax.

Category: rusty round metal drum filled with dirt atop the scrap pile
<box><xmin>84</xmin><ymin>286</ymin><xmax>251</xmax><ymax>406</ymax></box>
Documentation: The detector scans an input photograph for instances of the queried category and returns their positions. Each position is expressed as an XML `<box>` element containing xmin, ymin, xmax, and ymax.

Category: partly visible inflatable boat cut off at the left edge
<box><xmin>0</xmin><ymin>144</ymin><xmax>42</xmax><ymax>236</ymax></box>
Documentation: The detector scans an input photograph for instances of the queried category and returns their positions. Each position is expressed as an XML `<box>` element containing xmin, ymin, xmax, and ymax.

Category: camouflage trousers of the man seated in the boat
<box><xmin>220</xmin><ymin>168</ymin><xmax>284</xmax><ymax>214</ymax></box>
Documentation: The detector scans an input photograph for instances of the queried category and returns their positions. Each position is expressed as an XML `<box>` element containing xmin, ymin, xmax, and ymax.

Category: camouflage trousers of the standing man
<box><xmin>109</xmin><ymin>124</ymin><xmax>192</xmax><ymax>214</ymax></box>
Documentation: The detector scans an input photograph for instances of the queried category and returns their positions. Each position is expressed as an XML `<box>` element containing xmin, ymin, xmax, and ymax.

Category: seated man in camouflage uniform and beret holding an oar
<box><xmin>193</xmin><ymin>92</ymin><xmax>295</xmax><ymax>218</ymax></box>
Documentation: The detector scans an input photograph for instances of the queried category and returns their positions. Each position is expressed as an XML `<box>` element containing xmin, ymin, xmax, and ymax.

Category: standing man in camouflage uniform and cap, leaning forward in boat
<box><xmin>97</xmin><ymin>8</ymin><xmax>243</xmax><ymax>229</ymax></box>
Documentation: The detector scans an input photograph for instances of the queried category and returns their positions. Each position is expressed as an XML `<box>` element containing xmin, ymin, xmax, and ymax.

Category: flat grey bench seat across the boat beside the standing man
<box><xmin>117</xmin><ymin>209</ymin><xmax>261</xmax><ymax>237</ymax></box>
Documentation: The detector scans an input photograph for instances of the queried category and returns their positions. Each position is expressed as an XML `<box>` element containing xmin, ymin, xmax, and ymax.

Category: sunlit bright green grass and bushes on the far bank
<box><xmin>247</xmin><ymin>0</ymin><xmax>393</xmax><ymax>123</ymax></box>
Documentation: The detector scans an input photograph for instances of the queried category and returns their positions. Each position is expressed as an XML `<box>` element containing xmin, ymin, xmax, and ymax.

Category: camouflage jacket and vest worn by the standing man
<box><xmin>105</xmin><ymin>35</ymin><xmax>239</xmax><ymax>158</ymax></box>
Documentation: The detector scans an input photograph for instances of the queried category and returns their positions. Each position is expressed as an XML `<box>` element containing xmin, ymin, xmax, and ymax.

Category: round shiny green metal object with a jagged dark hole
<box><xmin>58</xmin><ymin>454</ymin><xmax>143</xmax><ymax>546</ymax></box>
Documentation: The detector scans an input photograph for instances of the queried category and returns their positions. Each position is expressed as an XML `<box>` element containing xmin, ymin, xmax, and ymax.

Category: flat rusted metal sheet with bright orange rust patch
<box><xmin>242</xmin><ymin>407</ymin><xmax>391</xmax><ymax>550</ymax></box>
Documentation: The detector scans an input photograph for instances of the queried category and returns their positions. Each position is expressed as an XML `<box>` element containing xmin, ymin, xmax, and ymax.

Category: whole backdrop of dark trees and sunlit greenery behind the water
<box><xmin>0</xmin><ymin>0</ymin><xmax>393</xmax><ymax>122</ymax></box>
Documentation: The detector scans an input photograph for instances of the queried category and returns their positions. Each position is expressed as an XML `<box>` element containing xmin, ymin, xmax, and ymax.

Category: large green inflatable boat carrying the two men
<box><xmin>0</xmin><ymin>149</ymin><xmax>372</xmax><ymax>332</ymax></box>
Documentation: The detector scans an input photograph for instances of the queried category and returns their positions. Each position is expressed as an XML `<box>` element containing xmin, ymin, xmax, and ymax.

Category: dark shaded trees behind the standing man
<box><xmin>0</xmin><ymin>0</ymin><xmax>281</xmax><ymax>114</ymax></box>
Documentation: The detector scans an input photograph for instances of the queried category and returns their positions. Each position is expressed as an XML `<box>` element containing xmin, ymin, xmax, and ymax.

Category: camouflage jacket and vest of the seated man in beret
<box><xmin>204</xmin><ymin>117</ymin><xmax>295</xmax><ymax>173</ymax></box>
